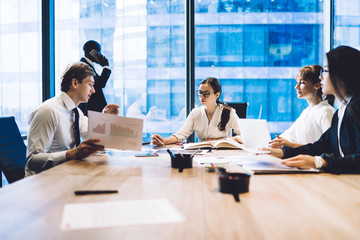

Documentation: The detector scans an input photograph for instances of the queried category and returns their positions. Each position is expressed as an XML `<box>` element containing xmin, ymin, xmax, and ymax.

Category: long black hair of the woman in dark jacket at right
<box><xmin>326</xmin><ymin>46</ymin><xmax>360</xmax><ymax>125</ymax></box>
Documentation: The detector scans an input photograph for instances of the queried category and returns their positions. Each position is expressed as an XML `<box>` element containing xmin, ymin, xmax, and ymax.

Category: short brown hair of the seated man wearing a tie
<box><xmin>61</xmin><ymin>62</ymin><xmax>95</xmax><ymax>92</ymax></box>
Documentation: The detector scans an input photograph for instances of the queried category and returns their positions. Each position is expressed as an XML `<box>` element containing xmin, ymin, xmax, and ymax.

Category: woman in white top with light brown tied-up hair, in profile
<box><xmin>270</xmin><ymin>65</ymin><xmax>335</xmax><ymax>148</ymax></box>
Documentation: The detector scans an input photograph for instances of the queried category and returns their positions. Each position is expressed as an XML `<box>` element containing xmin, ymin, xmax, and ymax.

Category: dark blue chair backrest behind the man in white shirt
<box><xmin>0</xmin><ymin>117</ymin><xmax>26</xmax><ymax>183</ymax></box>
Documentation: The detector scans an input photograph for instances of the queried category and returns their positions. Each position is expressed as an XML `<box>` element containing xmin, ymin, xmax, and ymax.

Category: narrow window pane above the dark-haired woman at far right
<box><xmin>334</xmin><ymin>0</ymin><xmax>360</xmax><ymax>49</ymax></box>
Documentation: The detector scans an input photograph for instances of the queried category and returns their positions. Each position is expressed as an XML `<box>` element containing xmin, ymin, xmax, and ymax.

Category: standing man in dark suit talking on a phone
<box><xmin>79</xmin><ymin>40</ymin><xmax>111</xmax><ymax>116</ymax></box>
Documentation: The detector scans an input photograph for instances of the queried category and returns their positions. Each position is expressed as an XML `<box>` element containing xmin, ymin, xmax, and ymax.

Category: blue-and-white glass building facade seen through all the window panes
<box><xmin>0</xmin><ymin>0</ymin><xmax>360</xmax><ymax>140</ymax></box>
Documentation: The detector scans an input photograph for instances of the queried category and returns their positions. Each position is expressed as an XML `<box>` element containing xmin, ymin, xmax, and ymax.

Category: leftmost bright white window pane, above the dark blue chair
<box><xmin>0</xmin><ymin>0</ymin><xmax>42</xmax><ymax>133</ymax></box>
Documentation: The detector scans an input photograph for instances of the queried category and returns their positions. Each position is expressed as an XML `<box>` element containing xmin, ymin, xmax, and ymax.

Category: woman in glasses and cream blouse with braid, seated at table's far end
<box><xmin>151</xmin><ymin>77</ymin><xmax>242</xmax><ymax>145</ymax></box>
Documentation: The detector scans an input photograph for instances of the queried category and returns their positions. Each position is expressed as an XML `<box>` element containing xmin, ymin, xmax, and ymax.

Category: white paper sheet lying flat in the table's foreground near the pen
<box><xmin>61</xmin><ymin>199</ymin><xmax>185</xmax><ymax>231</ymax></box>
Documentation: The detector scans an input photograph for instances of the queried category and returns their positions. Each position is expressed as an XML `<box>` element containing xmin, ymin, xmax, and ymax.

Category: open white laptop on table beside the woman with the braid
<box><xmin>239</xmin><ymin>119</ymin><xmax>271</xmax><ymax>149</ymax></box>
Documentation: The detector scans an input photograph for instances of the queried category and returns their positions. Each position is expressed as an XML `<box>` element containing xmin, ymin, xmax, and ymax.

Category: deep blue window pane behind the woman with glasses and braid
<box><xmin>195</xmin><ymin>0</ymin><xmax>323</xmax><ymax>133</ymax></box>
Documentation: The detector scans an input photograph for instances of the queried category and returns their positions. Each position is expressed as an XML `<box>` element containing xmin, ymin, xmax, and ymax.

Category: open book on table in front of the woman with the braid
<box><xmin>183</xmin><ymin>138</ymin><xmax>244</xmax><ymax>149</ymax></box>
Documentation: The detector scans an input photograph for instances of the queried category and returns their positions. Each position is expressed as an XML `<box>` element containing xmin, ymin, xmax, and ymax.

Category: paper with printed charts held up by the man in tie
<box><xmin>88</xmin><ymin>111</ymin><xmax>143</xmax><ymax>151</ymax></box>
